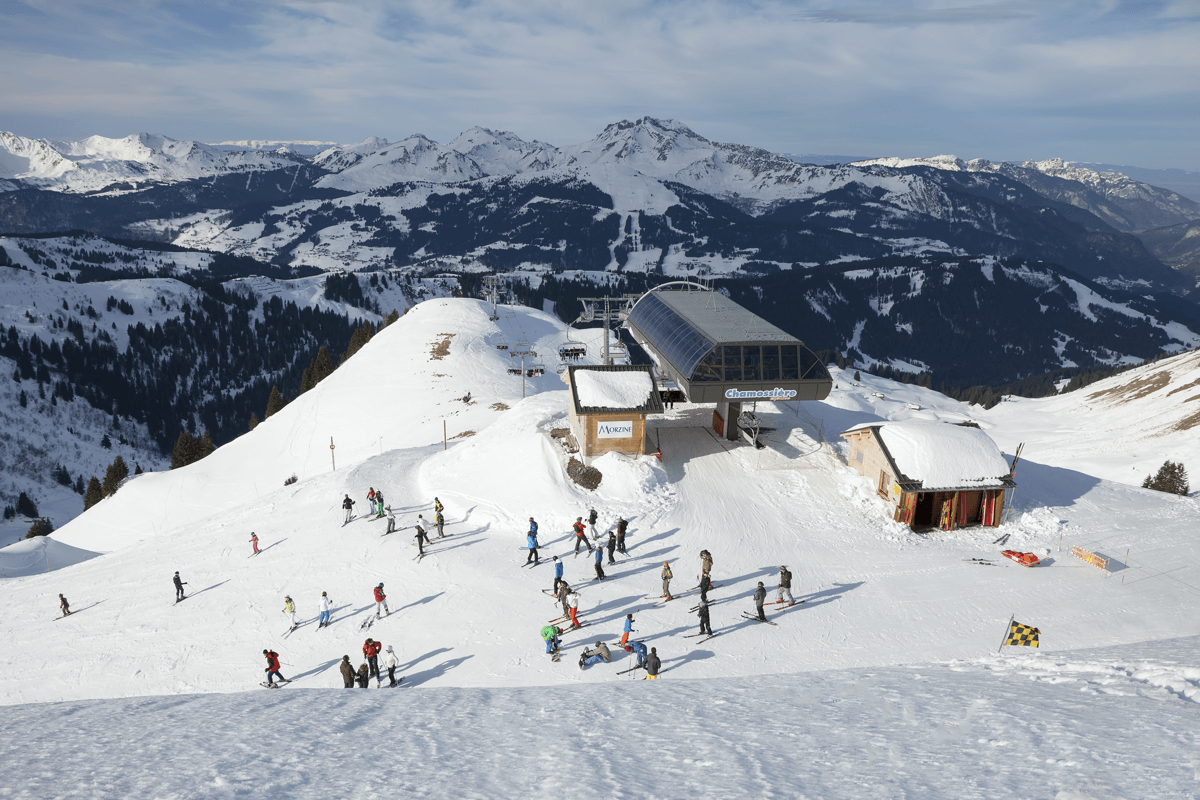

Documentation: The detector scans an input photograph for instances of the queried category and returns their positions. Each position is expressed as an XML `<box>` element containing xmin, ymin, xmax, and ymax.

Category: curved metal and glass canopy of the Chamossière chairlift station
<box><xmin>626</xmin><ymin>282</ymin><xmax>833</xmax><ymax>403</ymax></box>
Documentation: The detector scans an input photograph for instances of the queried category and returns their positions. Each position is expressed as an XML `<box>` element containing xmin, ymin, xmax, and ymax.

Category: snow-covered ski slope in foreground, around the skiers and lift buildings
<box><xmin>0</xmin><ymin>299</ymin><xmax>1200</xmax><ymax>800</ymax></box>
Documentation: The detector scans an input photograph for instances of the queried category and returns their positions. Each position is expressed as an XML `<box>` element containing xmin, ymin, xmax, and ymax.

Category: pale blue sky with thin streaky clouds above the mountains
<box><xmin>0</xmin><ymin>0</ymin><xmax>1200</xmax><ymax>169</ymax></box>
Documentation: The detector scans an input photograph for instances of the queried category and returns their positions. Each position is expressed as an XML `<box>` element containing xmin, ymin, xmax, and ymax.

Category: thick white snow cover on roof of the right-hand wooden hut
<box><xmin>847</xmin><ymin>420</ymin><xmax>1012</xmax><ymax>492</ymax></box>
